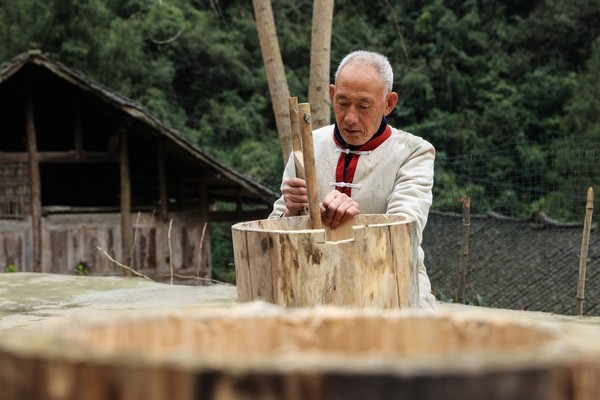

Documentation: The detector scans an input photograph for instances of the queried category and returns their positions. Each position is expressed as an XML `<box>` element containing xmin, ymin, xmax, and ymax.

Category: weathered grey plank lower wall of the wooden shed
<box><xmin>0</xmin><ymin>212</ymin><xmax>211</xmax><ymax>283</ymax></box>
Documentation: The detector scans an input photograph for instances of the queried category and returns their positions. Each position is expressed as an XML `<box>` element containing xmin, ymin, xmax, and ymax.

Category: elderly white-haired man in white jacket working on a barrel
<box><xmin>270</xmin><ymin>50</ymin><xmax>435</xmax><ymax>310</ymax></box>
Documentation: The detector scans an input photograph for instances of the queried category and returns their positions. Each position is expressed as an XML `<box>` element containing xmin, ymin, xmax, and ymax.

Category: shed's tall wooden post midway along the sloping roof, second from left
<box><xmin>119</xmin><ymin>127</ymin><xmax>133</xmax><ymax>267</ymax></box>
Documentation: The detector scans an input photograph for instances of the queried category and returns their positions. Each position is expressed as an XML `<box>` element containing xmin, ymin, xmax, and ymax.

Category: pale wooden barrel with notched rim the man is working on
<box><xmin>232</xmin><ymin>214</ymin><xmax>419</xmax><ymax>308</ymax></box>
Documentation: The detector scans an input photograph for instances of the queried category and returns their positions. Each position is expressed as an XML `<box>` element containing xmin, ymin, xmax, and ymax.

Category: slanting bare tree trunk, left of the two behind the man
<box><xmin>252</xmin><ymin>0</ymin><xmax>292</xmax><ymax>165</ymax></box>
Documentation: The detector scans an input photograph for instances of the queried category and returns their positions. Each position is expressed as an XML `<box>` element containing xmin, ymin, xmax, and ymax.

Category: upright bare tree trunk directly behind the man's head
<box><xmin>308</xmin><ymin>0</ymin><xmax>334</xmax><ymax>129</ymax></box>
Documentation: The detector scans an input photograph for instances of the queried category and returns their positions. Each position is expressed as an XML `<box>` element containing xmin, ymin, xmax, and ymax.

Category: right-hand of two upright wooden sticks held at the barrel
<box><xmin>298</xmin><ymin>103</ymin><xmax>323</xmax><ymax>229</ymax></box>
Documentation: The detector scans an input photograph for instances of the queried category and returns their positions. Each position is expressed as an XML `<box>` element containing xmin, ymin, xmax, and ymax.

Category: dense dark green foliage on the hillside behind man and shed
<box><xmin>0</xmin><ymin>0</ymin><xmax>600</xmax><ymax>279</ymax></box>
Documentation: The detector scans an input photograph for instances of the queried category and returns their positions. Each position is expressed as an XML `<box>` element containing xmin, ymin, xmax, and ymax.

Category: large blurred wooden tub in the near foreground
<box><xmin>0</xmin><ymin>303</ymin><xmax>600</xmax><ymax>400</ymax></box>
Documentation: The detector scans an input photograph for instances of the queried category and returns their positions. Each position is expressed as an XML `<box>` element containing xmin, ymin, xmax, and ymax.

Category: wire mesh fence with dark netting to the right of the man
<box><xmin>423</xmin><ymin>136</ymin><xmax>600</xmax><ymax>315</ymax></box>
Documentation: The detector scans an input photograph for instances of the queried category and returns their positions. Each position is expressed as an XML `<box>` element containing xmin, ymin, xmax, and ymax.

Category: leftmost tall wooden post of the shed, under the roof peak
<box><xmin>25</xmin><ymin>90</ymin><xmax>44</xmax><ymax>272</ymax></box>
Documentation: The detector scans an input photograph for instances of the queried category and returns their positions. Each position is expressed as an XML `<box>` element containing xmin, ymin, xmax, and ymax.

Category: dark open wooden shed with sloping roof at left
<box><xmin>0</xmin><ymin>52</ymin><xmax>275</xmax><ymax>280</ymax></box>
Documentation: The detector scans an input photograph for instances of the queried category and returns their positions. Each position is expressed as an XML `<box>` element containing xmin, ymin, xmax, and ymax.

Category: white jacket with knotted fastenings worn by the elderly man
<box><xmin>269</xmin><ymin>125</ymin><xmax>435</xmax><ymax>309</ymax></box>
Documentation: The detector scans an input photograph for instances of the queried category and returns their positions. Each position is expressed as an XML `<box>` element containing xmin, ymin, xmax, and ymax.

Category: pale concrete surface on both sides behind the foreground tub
<box><xmin>0</xmin><ymin>273</ymin><xmax>600</xmax><ymax>334</ymax></box>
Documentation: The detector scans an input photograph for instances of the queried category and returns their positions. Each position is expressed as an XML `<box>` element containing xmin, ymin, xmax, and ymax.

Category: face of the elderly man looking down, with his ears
<box><xmin>329</xmin><ymin>65</ymin><xmax>398</xmax><ymax>146</ymax></box>
